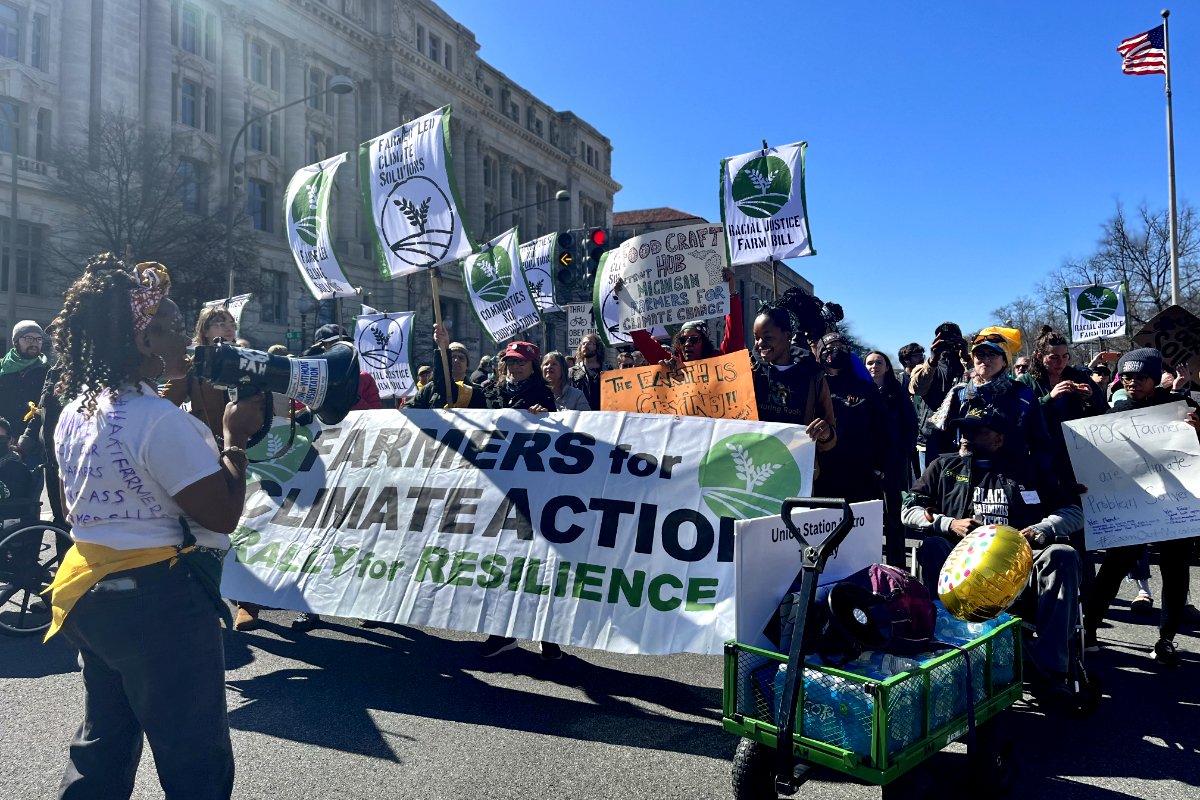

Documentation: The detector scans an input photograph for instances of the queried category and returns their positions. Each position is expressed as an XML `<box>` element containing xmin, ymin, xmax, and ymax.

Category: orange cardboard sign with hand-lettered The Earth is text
<box><xmin>600</xmin><ymin>350</ymin><xmax>758</xmax><ymax>420</ymax></box>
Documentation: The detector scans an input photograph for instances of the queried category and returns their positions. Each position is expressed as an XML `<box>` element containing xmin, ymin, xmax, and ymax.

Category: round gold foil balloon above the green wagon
<box><xmin>937</xmin><ymin>525</ymin><xmax>1033</xmax><ymax>622</ymax></box>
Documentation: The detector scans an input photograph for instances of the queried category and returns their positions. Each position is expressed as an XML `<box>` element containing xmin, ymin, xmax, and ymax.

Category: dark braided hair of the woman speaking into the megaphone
<box><xmin>54</xmin><ymin>253</ymin><xmax>142</xmax><ymax>415</ymax></box>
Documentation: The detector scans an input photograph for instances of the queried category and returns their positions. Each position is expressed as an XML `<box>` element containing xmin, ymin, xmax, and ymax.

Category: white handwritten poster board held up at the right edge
<box><xmin>1062</xmin><ymin>402</ymin><xmax>1200</xmax><ymax>549</ymax></box>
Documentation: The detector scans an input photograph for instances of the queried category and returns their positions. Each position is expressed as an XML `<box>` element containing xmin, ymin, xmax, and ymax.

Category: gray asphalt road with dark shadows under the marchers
<box><xmin>0</xmin><ymin>554</ymin><xmax>1200</xmax><ymax>800</ymax></box>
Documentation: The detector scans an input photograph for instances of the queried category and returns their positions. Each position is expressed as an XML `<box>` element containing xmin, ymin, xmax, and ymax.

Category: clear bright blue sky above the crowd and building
<box><xmin>440</xmin><ymin>0</ymin><xmax>1200</xmax><ymax>354</ymax></box>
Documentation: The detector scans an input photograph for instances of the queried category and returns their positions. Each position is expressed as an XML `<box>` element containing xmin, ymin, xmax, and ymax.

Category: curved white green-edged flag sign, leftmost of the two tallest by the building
<box><xmin>283</xmin><ymin>152</ymin><xmax>355</xmax><ymax>300</ymax></box>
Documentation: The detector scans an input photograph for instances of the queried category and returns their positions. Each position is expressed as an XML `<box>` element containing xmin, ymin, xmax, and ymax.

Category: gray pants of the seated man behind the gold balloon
<box><xmin>917</xmin><ymin>536</ymin><xmax>1082</xmax><ymax>674</ymax></box>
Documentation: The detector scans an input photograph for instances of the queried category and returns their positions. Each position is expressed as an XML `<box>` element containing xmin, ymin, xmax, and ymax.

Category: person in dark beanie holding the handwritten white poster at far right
<box><xmin>1084</xmin><ymin>348</ymin><xmax>1200</xmax><ymax>667</ymax></box>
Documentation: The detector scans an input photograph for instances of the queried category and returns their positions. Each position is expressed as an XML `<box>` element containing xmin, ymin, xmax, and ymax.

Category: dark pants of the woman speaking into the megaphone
<box><xmin>59</xmin><ymin>563</ymin><xmax>234</xmax><ymax>800</ymax></box>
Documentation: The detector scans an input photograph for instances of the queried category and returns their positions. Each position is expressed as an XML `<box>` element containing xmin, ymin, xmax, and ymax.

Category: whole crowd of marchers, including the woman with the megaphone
<box><xmin>0</xmin><ymin>254</ymin><xmax>1200</xmax><ymax>796</ymax></box>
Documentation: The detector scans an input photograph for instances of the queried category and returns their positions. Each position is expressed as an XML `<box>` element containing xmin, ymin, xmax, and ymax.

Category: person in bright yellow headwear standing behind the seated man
<box><xmin>926</xmin><ymin>326</ymin><xmax>1054</xmax><ymax>470</ymax></box>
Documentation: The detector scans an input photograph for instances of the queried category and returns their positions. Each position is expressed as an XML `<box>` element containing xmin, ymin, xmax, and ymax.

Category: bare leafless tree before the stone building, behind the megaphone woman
<box><xmin>52</xmin><ymin>113</ymin><xmax>259</xmax><ymax>312</ymax></box>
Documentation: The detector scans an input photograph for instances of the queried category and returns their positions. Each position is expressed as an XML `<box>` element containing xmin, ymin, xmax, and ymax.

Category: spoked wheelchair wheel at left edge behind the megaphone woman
<box><xmin>0</xmin><ymin>522</ymin><xmax>71</xmax><ymax>636</ymax></box>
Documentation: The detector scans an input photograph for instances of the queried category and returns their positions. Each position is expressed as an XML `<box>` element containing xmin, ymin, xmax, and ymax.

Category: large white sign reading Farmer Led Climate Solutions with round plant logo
<box><xmin>359</xmin><ymin>106</ymin><xmax>474</xmax><ymax>278</ymax></box>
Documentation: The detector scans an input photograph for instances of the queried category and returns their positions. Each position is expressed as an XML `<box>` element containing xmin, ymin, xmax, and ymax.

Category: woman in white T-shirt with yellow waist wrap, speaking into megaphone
<box><xmin>47</xmin><ymin>253</ymin><xmax>263</xmax><ymax>798</ymax></box>
